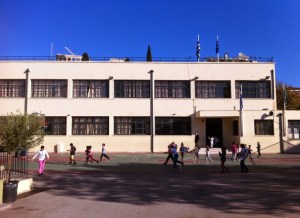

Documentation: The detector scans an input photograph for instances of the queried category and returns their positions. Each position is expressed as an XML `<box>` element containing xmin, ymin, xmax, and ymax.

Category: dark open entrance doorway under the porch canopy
<box><xmin>206</xmin><ymin>118</ymin><xmax>223</xmax><ymax>147</ymax></box>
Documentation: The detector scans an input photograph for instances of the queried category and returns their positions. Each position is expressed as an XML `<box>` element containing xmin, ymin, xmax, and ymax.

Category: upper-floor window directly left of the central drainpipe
<box><xmin>115</xmin><ymin>80</ymin><xmax>150</xmax><ymax>98</ymax></box>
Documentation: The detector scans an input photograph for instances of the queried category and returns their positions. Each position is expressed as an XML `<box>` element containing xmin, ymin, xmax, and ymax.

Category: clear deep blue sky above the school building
<box><xmin>0</xmin><ymin>0</ymin><xmax>300</xmax><ymax>87</ymax></box>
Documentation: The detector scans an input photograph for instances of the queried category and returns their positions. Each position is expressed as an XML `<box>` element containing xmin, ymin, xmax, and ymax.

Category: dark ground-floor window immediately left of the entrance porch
<box><xmin>155</xmin><ymin>117</ymin><xmax>191</xmax><ymax>135</ymax></box>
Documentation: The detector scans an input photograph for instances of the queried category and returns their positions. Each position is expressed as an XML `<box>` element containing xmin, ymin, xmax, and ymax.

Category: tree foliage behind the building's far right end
<box><xmin>276</xmin><ymin>82</ymin><xmax>300</xmax><ymax>110</ymax></box>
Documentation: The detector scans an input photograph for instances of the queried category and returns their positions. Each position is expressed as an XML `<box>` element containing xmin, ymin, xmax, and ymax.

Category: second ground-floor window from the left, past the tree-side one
<box><xmin>72</xmin><ymin>117</ymin><xmax>108</xmax><ymax>135</ymax></box>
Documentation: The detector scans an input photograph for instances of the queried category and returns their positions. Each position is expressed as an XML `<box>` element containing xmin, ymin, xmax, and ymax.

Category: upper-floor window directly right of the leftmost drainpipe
<box><xmin>31</xmin><ymin>80</ymin><xmax>67</xmax><ymax>98</ymax></box>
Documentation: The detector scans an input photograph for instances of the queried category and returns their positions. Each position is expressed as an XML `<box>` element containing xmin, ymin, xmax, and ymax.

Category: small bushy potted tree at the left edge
<box><xmin>0</xmin><ymin>112</ymin><xmax>45</xmax><ymax>182</ymax></box>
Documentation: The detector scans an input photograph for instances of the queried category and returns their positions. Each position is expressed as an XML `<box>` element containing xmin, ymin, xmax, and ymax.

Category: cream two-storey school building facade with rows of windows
<box><xmin>0</xmin><ymin>61</ymin><xmax>300</xmax><ymax>153</ymax></box>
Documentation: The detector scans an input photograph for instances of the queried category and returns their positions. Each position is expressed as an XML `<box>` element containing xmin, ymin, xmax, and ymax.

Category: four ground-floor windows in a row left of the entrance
<box><xmin>45</xmin><ymin>117</ymin><xmax>191</xmax><ymax>135</ymax></box>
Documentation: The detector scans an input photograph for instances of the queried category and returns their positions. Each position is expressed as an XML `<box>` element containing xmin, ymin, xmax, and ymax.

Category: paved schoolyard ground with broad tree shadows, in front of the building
<box><xmin>0</xmin><ymin>153</ymin><xmax>300</xmax><ymax>218</ymax></box>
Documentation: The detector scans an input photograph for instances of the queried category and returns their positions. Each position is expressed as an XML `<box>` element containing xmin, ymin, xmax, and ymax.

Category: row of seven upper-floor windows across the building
<box><xmin>0</xmin><ymin>80</ymin><xmax>271</xmax><ymax>98</ymax></box>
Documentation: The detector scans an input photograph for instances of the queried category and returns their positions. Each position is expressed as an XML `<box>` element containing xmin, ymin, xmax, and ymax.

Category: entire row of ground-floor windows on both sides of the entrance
<box><xmin>45</xmin><ymin>117</ymin><xmax>300</xmax><ymax>139</ymax></box>
